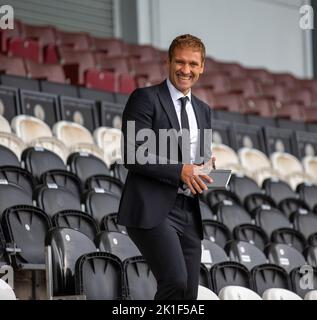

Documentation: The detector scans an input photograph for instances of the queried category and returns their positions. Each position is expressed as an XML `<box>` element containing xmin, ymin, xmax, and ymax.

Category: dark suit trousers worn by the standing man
<box><xmin>127</xmin><ymin>194</ymin><xmax>201</xmax><ymax>300</ymax></box>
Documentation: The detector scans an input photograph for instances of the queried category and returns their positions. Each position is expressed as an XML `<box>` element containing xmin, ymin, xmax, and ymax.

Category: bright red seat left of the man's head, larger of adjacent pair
<box><xmin>85</xmin><ymin>69</ymin><xmax>117</xmax><ymax>92</ymax></box>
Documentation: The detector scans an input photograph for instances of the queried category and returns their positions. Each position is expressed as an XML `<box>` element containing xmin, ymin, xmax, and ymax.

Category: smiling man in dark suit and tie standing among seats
<box><xmin>118</xmin><ymin>35</ymin><xmax>212</xmax><ymax>300</ymax></box>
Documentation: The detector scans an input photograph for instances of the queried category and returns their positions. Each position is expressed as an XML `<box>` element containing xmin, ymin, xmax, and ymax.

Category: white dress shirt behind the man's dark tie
<box><xmin>167</xmin><ymin>79</ymin><xmax>198</xmax><ymax>163</ymax></box>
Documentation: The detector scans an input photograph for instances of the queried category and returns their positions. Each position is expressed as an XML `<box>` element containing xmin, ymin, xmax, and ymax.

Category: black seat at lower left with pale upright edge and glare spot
<box><xmin>45</xmin><ymin>228</ymin><xmax>97</xmax><ymax>299</ymax></box>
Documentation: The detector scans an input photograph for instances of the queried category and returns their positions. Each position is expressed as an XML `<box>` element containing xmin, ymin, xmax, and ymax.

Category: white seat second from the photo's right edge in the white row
<box><xmin>270</xmin><ymin>152</ymin><xmax>312</xmax><ymax>190</ymax></box>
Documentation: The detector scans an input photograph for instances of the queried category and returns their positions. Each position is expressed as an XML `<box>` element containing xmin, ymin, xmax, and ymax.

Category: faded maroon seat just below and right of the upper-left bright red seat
<box><xmin>25</xmin><ymin>60</ymin><xmax>66</xmax><ymax>83</ymax></box>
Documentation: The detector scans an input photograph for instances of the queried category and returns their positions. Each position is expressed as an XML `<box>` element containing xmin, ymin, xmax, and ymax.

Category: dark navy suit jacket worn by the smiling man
<box><xmin>118</xmin><ymin>81</ymin><xmax>211</xmax><ymax>237</ymax></box>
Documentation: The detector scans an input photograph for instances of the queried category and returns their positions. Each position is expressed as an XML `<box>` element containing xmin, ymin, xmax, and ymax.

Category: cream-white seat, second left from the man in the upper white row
<box><xmin>53</xmin><ymin>121</ymin><xmax>94</xmax><ymax>148</ymax></box>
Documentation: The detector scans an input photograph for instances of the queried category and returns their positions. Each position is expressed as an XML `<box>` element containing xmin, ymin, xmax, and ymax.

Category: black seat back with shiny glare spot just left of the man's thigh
<box><xmin>95</xmin><ymin>231</ymin><xmax>141</xmax><ymax>261</ymax></box>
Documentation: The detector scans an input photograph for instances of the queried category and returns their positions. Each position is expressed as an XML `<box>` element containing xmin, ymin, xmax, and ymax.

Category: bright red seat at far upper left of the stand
<box><xmin>8</xmin><ymin>38</ymin><xmax>42</xmax><ymax>63</ymax></box>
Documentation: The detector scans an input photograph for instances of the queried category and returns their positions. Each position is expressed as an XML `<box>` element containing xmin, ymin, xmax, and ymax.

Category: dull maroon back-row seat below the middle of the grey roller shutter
<box><xmin>56</xmin><ymin>30</ymin><xmax>92</xmax><ymax>50</ymax></box>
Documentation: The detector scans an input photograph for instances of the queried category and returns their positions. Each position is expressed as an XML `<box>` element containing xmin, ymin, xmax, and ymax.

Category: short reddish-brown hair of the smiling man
<box><xmin>168</xmin><ymin>34</ymin><xmax>206</xmax><ymax>62</ymax></box>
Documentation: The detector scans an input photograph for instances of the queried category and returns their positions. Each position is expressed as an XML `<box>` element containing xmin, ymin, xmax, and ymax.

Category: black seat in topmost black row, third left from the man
<box><xmin>21</xmin><ymin>147</ymin><xmax>66</xmax><ymax>181</ymax></box>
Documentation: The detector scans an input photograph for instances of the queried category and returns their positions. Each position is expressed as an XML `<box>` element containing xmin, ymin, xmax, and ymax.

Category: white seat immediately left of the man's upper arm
<box><xmin>93</xmin><ymin>127</ymin><xmax>122</xmax><ymax>166</ymax></box>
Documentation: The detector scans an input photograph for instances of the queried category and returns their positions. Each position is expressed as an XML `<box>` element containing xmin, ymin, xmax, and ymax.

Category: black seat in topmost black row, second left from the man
<box><xmin>67</xmin><ymin>152</ymin><xmax>110</xmax><ymax>186</ymax></box>
